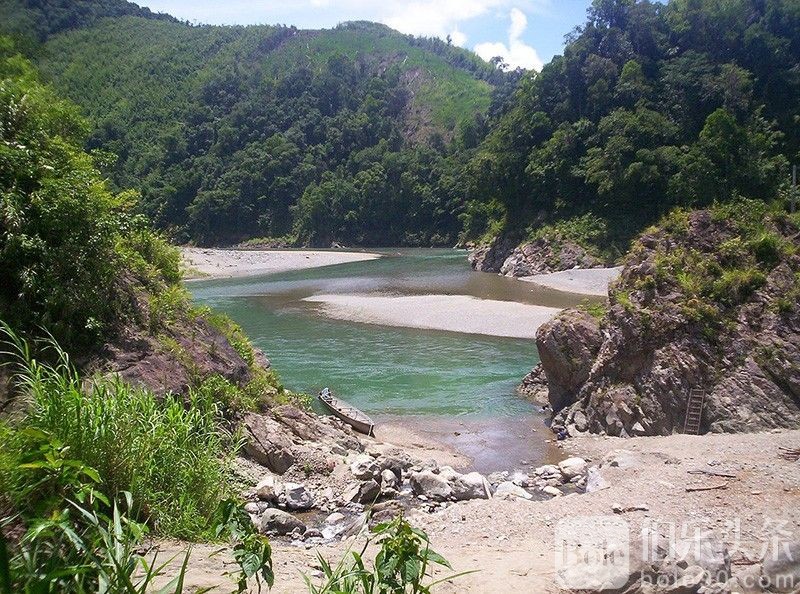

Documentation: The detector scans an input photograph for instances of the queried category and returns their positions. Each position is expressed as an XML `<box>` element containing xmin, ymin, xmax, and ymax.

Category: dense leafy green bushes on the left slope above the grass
<box><xmin>0</xmin><ymin>47</ymin><xmax>186</xmax><ymax>350</ymax></box>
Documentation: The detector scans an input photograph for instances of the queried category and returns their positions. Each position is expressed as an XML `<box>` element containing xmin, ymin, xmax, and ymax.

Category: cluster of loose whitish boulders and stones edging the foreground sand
<box><xmin>245</xmin><ymin>453</ymin><xmax>587</xmax><ymax>542</ymax></box>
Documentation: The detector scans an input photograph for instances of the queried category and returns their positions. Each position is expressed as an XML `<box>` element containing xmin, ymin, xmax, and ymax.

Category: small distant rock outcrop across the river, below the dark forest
<box><xmin>469</xmin><ymin>238</ymin><xmax>604</xmax><ymax>277</ymax></box>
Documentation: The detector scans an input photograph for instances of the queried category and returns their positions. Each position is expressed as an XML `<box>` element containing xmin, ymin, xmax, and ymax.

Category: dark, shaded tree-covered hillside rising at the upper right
<box><xmin>466</xmin><ymin>0</ymin><xmax>800</xmax><ymax>251</ymax></box>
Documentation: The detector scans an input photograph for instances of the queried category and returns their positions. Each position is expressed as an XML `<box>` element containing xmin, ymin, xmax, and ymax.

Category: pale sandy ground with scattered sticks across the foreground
<box><xmin>155</xmin><ymin>430</ymin><xmax>800</xmax><ymax>594</ymax></box>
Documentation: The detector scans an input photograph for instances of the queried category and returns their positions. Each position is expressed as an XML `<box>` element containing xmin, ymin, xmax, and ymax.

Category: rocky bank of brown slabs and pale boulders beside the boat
<box><xmin>233</xmin><ymin>398</ymin><xmax>587</xmax><ymax>545</ymax></box>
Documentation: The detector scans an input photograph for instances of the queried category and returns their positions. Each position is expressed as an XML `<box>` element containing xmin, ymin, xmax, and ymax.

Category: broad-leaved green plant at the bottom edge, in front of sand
<box><xmin>305</xmin><ymin>516</ymin><xmax>470</xmax><ymax>594</ymax></box>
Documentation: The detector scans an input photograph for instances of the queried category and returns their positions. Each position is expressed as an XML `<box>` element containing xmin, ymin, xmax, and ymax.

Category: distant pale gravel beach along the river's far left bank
<box><xmin>181</xmin><ymin>248</ymin><xmax>380</xmax><ymax>279</ymax></box>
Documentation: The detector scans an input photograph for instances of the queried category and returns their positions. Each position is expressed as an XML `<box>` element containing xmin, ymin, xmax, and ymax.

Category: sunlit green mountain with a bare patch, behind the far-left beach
<box><xmin>1</xmin><ymin>0</ymin><xmax>505</xmax><ymax>245</ymax></box>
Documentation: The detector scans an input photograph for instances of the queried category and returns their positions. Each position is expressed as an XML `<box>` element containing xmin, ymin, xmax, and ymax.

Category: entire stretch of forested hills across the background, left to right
<box><xmin>3</xmin><ymin>0</ymin><xmax>800</xmax><ymax>250</ymax></box>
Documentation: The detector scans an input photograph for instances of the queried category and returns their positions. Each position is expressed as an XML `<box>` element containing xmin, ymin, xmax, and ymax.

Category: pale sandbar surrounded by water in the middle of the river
<box><xmin>304</xmin><ymin>295</ymin><xmax>561</xmax><ymax>338</ymax></box>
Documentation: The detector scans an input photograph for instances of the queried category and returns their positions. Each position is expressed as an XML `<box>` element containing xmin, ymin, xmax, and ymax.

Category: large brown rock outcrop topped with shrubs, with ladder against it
<box><xmin>537</xmin><ymin>204</ymin><xmax>800</xmax><ymax>436</ymax></box>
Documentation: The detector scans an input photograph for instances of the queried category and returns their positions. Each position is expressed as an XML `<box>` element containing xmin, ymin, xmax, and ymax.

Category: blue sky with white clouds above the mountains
<box><xmin>138</xmin><ymin>0</ymin><xmax>591</xmax><ymax>70</ymax></box>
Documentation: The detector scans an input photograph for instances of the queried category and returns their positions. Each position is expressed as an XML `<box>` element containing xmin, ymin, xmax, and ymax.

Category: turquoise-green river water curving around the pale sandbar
<box><xmin>189</xmin><ymin>249</ymin><xmax>580</xmax><ymax>472</ymax></box>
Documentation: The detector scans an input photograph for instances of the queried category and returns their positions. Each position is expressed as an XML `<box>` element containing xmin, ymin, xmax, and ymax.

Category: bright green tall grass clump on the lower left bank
<box><xmin>0</xmin><ymin>328</ymin><xmax>238</xmax><ymax>539</ymax></box>
